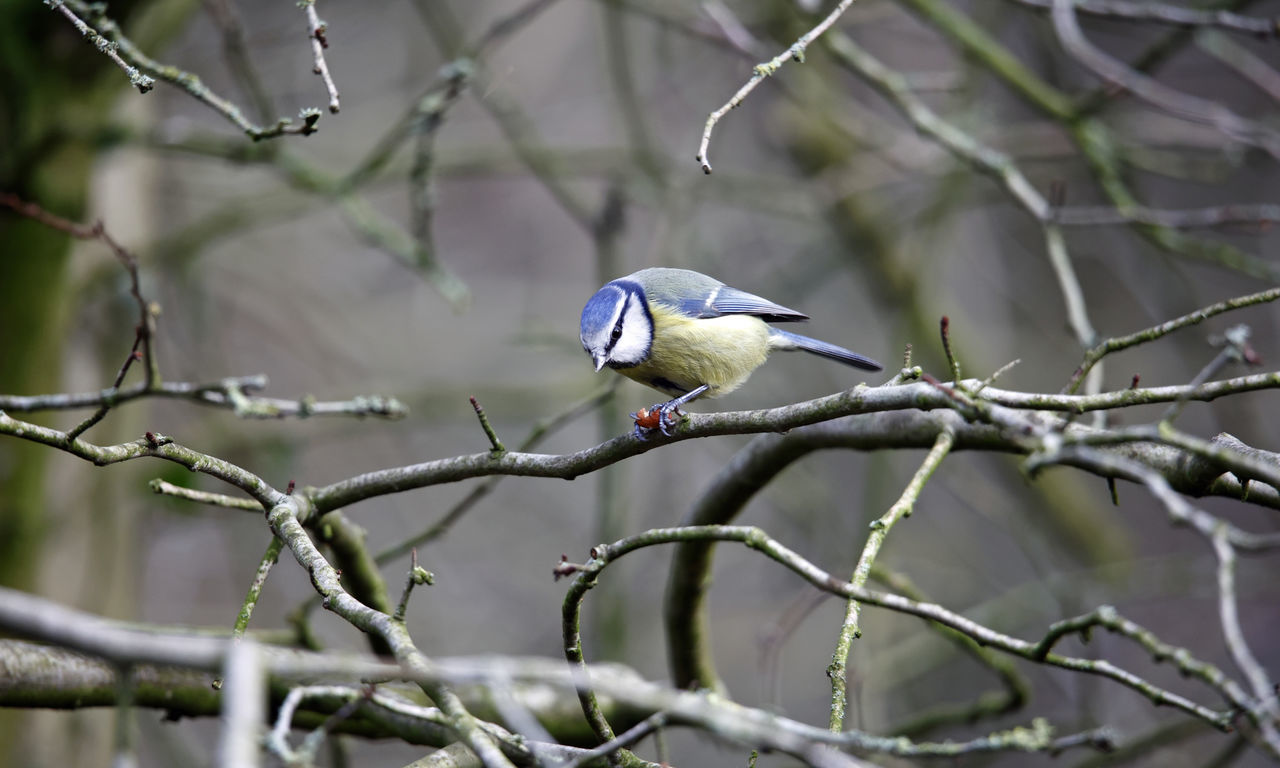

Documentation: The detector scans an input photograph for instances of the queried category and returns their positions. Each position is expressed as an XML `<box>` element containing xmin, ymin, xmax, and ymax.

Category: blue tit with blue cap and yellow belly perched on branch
<box><xmin>580</xmin><ymin>268</ymin><xmax>883</xmax><ymax>438</ymax></box>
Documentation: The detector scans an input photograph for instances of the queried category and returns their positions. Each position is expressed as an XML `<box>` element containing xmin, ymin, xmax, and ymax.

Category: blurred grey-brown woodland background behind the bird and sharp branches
<box><xmin>0</xmin><ymin>0</ymin><xmax>1280</xmax><ymax>767</ymax></box>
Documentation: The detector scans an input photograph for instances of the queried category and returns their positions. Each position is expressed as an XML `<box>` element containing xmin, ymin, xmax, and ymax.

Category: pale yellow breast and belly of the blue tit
<box><xmin>617</xmin><ymin>305</ymin><xmax>769</xmax><ymax>397</ymax></box>
